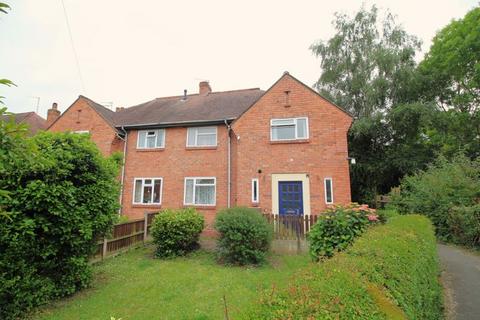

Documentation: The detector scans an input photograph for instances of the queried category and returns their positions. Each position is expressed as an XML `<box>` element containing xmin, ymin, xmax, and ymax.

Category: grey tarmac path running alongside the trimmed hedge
<box><xmin>438</xmin><ymin>244</ymin><xmax>480</xmax><ymax>320</ymax></box>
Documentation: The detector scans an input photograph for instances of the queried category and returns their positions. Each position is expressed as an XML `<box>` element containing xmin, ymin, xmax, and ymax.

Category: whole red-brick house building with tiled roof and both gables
<box><xmin>49</xmin><ymin>73</ymin><xmax>353</xmax><ymax>229</ymax></box>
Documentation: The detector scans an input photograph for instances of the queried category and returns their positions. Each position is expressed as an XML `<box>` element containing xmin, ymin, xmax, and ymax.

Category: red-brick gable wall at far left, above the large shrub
<box><xmin>48</xmin><ymin>98</ymin><xmax>123</xmax><ymax>156</ymax></box>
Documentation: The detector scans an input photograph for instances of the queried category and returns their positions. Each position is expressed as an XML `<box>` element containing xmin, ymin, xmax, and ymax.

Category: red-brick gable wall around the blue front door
<box><xmin>233</xmin><ymin>75</ymin><xmax>352</xmax><ymax>214</ymax></box>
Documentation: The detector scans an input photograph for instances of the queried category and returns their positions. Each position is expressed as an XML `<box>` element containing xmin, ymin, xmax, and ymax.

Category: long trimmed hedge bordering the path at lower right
<box><xmin>250</xmin><ymin>215</ymin><xmax>443</xmax><ymax>320</ymax></box>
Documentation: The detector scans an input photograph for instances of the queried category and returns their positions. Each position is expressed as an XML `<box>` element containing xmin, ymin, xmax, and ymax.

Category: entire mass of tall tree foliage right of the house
<box><xmin>311</xmin><ymin>6</ymin><xmax>480</xmax><ymax>203</ymax></box>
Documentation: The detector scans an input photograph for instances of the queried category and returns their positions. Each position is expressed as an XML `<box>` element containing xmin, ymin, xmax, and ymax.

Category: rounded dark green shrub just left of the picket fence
<box><xmin>215</xmin><ymin>207</ymin><xmax>272</xmax><ymax>265</ymax></box>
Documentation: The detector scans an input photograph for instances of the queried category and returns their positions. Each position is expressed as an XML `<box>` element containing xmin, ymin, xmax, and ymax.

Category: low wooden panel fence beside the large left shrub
<box><xmin>93</xmin><ymin>213</ymin><xmax>157</xmax><ymax>261</ymax></box>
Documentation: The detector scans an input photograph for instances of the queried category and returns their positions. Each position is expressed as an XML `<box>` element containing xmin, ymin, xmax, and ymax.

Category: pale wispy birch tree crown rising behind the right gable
<box><xmin>310</xmin><ymin>6</ymin><xmax>420</xmax><ymax>117</ymax></box>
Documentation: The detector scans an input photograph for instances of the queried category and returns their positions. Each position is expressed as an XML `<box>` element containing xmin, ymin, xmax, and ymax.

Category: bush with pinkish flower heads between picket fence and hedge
<box><xmin>308</xmin><ymin>204</ymin><xmax>379</xmax><ymax>259</ymax></box>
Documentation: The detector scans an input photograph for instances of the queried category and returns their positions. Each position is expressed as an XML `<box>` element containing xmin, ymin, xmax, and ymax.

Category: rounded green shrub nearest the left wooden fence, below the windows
<box><xmin>152</xmin><ymin>208</ymin><xmax>205</xmax><ymax>258</ymax></box>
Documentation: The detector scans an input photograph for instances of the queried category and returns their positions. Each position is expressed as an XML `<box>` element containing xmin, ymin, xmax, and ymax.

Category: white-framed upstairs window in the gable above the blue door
<box><xmin>270</xmin><ymin>118</ymin><xmax>308</xmax><ymax>141</ymax></box>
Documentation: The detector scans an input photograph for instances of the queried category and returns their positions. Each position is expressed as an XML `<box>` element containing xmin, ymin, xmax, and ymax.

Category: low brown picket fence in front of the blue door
<box><xmin>263</xmin><ymin>213</ymin><xmax>318</xmax><ymax>240</ymax></box>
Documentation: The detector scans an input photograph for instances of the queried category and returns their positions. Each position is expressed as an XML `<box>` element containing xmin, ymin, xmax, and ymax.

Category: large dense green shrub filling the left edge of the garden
<box><xmin>0</xmin><ymin>130</ymin><xmax>119</xmax><ymax>319</ymax></box>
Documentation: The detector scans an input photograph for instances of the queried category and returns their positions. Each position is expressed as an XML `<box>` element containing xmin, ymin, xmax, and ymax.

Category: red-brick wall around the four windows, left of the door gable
<box><xmin>122</xmin><ymin>125</ymin><xmax>227</xmax><ymax>228</ymax></box>
